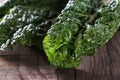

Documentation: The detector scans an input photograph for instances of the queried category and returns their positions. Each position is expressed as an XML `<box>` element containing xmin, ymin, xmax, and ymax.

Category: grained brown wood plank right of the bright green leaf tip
<box><xmin>76</xmin><ymin>30</ymin><xmax>120</xmax><ymax>80</ymax></box>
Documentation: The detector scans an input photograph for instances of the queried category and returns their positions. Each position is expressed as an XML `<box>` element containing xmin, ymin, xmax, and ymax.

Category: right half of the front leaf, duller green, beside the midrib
<box><xmin>75</xmin><ymin>0</ymin><xmax>120</xmax><ymax>56</ymax></box>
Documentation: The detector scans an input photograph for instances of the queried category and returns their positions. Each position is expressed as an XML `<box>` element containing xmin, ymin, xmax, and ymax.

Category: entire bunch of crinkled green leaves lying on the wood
<box><xmin>0</xmin><ymin>0</ymin><xmax>120</xmax><ymax>68</ymax></box>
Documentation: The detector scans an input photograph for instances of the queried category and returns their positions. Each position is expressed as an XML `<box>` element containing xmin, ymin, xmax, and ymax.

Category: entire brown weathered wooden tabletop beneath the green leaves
<box><xmin>0</xmin><ymin>30</ymin><xmax>120</xmax><ymax>80</ymax></box>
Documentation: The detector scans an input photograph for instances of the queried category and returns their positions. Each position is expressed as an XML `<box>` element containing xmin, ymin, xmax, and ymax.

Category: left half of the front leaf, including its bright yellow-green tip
<box><xmin>43</xmin><ymin>0</ymin><xmax>102</xmax><ymax>68</ymax></box>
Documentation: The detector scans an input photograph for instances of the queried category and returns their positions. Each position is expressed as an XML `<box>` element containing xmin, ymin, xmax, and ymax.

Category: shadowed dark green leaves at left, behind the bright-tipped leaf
<box><xmin>0</xmin><ymin>0</ymin><xmax>67</xmax><ymax>50</ymax></box>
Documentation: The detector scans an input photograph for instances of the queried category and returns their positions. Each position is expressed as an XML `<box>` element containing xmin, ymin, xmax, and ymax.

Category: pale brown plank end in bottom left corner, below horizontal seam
<box><xmin>0</xmin><ymin>56</ymin><xmax>22</xmax><ymax>80</ymax></box>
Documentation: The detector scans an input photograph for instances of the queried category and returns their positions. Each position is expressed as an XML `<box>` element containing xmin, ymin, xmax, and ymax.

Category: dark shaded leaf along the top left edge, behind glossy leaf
<box><xmin>0</xmin><ymin>0</ymin><xmax>68</xmax><ymax>17</ymax></box>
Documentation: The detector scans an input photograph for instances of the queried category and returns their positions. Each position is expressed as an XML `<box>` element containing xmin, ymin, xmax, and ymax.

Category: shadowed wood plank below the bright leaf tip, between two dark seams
<box><xmin>19</xmin><ymin>47</ymin><xmax>75</xmax><ymax>80</ymax></box>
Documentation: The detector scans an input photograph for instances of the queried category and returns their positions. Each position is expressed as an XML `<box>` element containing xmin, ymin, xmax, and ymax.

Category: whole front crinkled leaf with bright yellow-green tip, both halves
<box><xmin>43</xmin><ymin>0</ymin><xmax>120</xmax><ymax>68</ymax></box>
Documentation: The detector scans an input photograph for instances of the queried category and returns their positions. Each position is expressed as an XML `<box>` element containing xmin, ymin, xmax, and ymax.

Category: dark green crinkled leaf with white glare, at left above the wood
<box><xmin>0</xmin><ymin>6</ymin><xmax>51</xmax><ymax>49</ymax></box>
